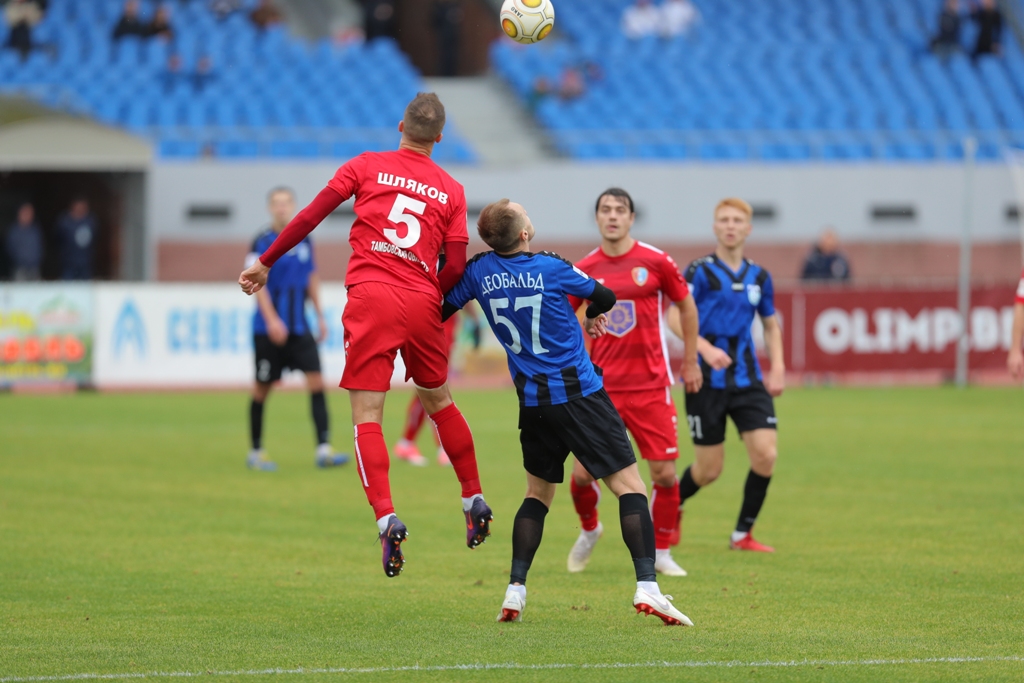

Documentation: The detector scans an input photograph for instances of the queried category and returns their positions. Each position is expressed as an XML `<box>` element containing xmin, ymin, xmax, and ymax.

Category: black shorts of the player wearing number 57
<box><xmin>519</xmin><ymin>389</ymin><xmax>637</xmax><ymax>483</ymax></box>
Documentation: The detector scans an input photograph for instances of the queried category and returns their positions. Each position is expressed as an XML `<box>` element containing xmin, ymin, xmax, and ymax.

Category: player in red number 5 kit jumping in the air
<box><xmin>239</xmin><ymin>93</ymin><xmax>492</xmax><ymax>577</ymax></box>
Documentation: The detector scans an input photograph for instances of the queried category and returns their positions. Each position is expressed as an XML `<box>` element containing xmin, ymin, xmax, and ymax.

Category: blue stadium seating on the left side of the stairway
<box><xmin>0</xmin><ymin>0</ymin><xmax>476</xmax><ymax>163</ymax></box>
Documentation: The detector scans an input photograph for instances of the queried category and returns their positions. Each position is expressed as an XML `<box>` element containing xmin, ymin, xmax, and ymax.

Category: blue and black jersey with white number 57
<box><xmin>444</xmin><ymin>252</ymin><xmax>603</xmax><ymax>405</ymax></box>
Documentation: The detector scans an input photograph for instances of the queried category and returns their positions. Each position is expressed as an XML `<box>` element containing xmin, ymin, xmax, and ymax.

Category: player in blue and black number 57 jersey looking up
<box><xmin>444</xmin><ymin>200</ymin><xmax>692</xmax><ymax>626</ymax></box>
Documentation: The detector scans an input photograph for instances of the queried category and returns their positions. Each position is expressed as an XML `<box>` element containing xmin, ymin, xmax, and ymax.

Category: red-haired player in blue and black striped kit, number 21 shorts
<box><xmin>669</xmin><ymin>199</ymin><xmax>785</xmax><ymax>552</ymax></box>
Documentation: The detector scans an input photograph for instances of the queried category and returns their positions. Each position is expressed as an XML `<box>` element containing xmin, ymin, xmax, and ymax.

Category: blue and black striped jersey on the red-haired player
<box><xmin>686</xmin><ymin>254</ymin><xmax>775</xmax><ymax>389</ymax></box>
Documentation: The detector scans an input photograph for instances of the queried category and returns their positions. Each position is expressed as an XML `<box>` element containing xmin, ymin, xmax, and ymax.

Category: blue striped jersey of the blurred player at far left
<box><xmin>246</xmin><ymin>229</ymin><xmax>316</xmax><ymax>336</ymax></box>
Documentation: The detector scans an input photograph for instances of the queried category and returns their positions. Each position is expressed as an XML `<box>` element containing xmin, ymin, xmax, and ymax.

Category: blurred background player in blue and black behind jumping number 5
<box><xmin>246</xmin><ymin>187</ymin><xmax>348</xmax><ymax>471</ymax></box>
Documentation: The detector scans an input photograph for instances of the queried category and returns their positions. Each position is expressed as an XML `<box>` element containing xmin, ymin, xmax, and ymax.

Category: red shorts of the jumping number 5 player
<box><xmin>341</xmin><ymin>283</ymin><xmax>449</xmax><ymax>391</ymax></box>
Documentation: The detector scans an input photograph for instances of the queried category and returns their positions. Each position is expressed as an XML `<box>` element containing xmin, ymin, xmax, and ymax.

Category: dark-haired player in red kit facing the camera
<box><xmin>567</xmin><ymin>187</ymin><xmax>702</xmax><ymax>577</ymax></box>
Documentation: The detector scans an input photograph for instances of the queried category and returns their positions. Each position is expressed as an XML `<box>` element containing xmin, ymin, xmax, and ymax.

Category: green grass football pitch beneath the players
<box><xmin>0</xmin><ymin>389</ymin><xmax>1024</xmax><ymax>683</ymax></box>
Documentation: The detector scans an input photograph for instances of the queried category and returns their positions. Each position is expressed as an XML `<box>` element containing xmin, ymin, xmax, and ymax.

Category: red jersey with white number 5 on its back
<box><xmin>328</xmin><ymin>150</ymin><xmax>469</xmax><ymax>294</ymax></box>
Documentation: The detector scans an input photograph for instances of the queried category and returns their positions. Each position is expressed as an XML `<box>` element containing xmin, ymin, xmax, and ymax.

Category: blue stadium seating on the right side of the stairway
<box><xmin>493</xmin><ymin>0</ymin><xmax>1024</xmax><ymax>162</ymax></box>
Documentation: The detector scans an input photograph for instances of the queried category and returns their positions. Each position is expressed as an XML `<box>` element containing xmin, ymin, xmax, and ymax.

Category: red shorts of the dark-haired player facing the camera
<box><xmin>608</xmin><ymin>387</ymin><xmax>679</xmax><ymax>460</ymax></box>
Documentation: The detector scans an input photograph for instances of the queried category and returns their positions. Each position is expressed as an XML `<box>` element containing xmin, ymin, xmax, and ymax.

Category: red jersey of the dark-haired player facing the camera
<box><xmin>570</xmin><ymin>242</ymin><xmax>690</xmax><ymax>391</ymax></box>
